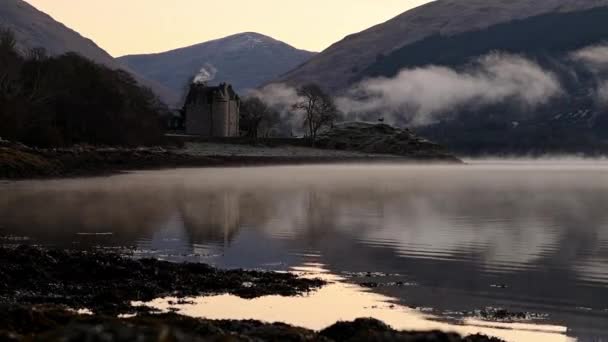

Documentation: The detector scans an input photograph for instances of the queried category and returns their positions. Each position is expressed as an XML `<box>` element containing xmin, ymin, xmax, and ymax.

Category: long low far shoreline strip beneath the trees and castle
<box><xmin>0</xmin><ymin>144</ymin><xmax>463</xmax><ymax>180</ymax></box>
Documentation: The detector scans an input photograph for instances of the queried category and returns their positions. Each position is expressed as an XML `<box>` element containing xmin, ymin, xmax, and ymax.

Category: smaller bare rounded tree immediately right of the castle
<box><xmin>240</xmin><ymin>97</ymin><xmax>279</xmax><ymax>139</ymax></box>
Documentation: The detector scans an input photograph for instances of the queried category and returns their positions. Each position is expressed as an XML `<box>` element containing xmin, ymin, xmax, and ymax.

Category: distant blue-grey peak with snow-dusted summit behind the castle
<box><xmin>119</xmin><ymin>32</ymin><xmax>314</xmax><ymax>101</ymax></box>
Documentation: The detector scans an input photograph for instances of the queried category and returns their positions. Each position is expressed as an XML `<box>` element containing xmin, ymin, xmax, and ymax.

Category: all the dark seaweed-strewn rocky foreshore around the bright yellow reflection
<box><xmin>0</xmin><ymin>246</ymin><xmax>499</xmax><ymax>342</ymax></box>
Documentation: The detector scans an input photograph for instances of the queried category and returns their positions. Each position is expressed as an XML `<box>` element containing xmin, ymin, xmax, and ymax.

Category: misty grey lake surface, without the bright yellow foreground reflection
<box><xmin>0</xmin><ymin>160</ymin><xmax>608</xmax><ymax>336</ymax></box>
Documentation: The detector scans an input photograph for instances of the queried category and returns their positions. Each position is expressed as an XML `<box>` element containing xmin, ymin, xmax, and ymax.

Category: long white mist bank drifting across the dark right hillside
<box><xmin>337</xmin><ymin>53</ymin><xmax>562</xmax><ymax>124</ymax></box>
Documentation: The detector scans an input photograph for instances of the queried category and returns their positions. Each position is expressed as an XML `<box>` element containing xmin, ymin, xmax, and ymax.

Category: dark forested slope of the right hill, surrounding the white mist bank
<box><xmin>364</xmin><ymin>6</ymin><xmax>608</xmax><ymax>155</ymax></box>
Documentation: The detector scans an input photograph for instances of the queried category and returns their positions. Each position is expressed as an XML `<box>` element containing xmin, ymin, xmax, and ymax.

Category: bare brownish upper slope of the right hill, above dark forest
<box><xmin>276</xmin><ymin>0</ymin><xmax>608</xmax><ymax>91</ymax></box>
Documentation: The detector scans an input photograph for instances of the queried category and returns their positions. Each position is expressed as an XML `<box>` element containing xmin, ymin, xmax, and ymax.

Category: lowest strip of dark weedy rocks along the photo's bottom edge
<box><xmin>0</xmin><ymin>306</ymin><xmax>500</xmax><ymax>342</ymax></box>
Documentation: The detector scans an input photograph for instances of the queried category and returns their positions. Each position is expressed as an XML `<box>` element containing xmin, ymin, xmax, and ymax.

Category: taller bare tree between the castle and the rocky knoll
<box><xmin>293</xmin><ymin>84</ymin><xmax>339</xmax><ymax>146</ymax></box>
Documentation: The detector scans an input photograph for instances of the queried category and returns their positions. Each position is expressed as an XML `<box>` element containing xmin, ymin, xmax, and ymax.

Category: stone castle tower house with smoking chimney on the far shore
<box><xmin>184</xmin><ymin>83</ymin><xmax>241</xmax><ymax>137</ymax></box>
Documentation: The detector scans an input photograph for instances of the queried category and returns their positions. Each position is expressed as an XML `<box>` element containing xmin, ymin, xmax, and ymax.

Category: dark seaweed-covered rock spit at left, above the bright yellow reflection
<box><xmin>0</xmin><ymin>246</ymin><xmax>324</xmax><ymax>314</ymax></box>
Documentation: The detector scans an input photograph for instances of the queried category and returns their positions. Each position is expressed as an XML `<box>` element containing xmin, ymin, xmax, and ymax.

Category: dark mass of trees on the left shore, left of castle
<box><xmin>0</xmin><ymin>29</ymin><xmax>166</xmax><ymax>147</ymax></box>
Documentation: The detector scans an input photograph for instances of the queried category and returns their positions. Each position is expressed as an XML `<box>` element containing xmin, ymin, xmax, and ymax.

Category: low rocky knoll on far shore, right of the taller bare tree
<box><xmin>316</xmin><ymin>122</ymin><xmax>459</xmax><ymax>162</ymax></box>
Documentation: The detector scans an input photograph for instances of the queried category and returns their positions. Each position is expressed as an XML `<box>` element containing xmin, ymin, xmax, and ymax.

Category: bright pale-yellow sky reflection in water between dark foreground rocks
<box><xmin>140</xmin><ymin>264</ymin><xmax>573</xmax><ymax>342</ymax></box>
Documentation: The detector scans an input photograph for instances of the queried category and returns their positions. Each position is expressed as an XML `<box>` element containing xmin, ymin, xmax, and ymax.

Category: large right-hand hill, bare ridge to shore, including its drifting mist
<box><xmin>278</xmin><ymin>0</ymin><xmax>608</xmax><ymax>155</ymax></box>
